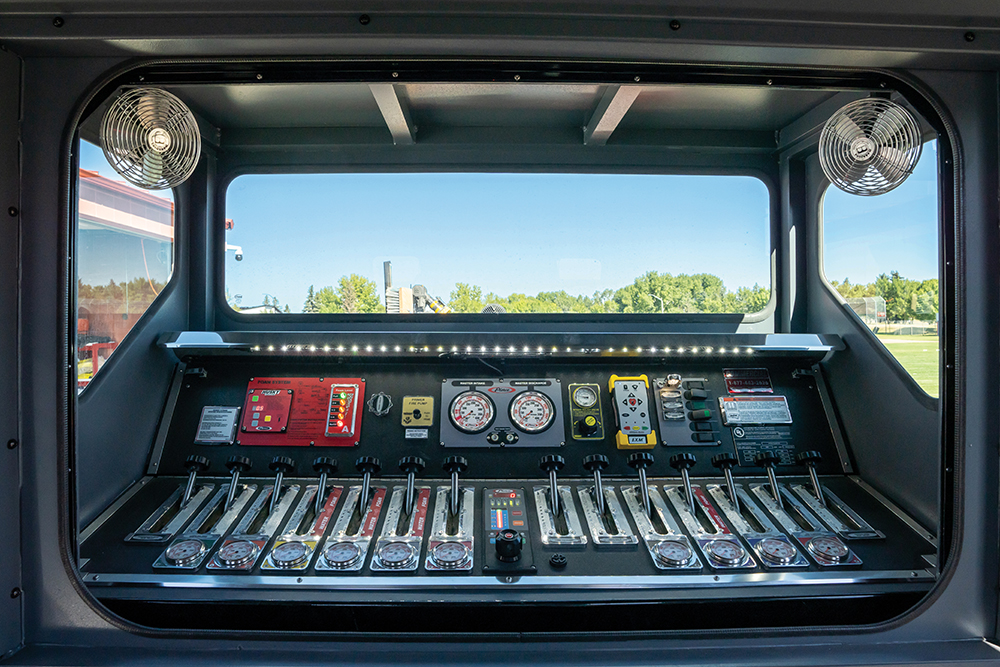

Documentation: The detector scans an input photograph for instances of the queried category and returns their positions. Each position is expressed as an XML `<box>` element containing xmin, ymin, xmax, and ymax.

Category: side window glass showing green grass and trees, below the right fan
<box><xmin>823</xmin><ymin>141</ymin><xmax>939</xmax><ymax>396</ymax></box>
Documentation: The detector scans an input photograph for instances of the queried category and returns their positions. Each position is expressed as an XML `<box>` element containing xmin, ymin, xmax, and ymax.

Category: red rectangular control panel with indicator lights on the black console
<box><xmin>236</xmin><ymin>377</ymin><xmax>365</xmax><ymax>447</ymax></box>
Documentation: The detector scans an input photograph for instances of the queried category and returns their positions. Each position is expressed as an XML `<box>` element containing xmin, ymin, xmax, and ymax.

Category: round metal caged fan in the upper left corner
<box><xmin>101</xmin><ymin>88</ymin><xmax>201</xmax><ymax>190</ymax></box>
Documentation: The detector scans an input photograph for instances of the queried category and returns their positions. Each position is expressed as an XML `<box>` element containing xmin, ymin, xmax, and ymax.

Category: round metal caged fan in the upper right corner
<box><xmin>819</xmin><ymin>97</ymin><xmax>922</xmax><ymax>196</ymax></box>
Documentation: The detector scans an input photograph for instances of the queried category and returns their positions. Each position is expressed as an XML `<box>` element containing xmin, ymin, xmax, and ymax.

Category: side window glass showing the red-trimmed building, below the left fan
<box><xmin>76</xmin><ymin>141</ymin><xmax>174</xmax><ymax>389</ymax></box>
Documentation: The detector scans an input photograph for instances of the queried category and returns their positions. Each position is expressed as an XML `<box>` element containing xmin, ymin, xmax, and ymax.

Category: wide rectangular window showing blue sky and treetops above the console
<box><xmin>226</xmin><ymin>173</ymin><xmax>771</xmax><ymax>316</ymax></box>
